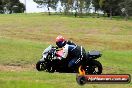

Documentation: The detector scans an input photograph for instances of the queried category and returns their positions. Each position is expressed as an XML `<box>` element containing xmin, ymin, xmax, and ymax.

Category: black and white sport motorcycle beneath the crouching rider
<box><xmin>36</xmin><ymin>45</ymin><xmax>102</xmax><ymax>74</ymax></box>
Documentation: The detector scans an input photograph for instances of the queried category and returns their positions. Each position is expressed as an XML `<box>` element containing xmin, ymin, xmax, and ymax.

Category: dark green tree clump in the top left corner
<box><xmin>0</xmin><ymin>0</ymin><xmax>25</xmax><ymax>14</ymax></box>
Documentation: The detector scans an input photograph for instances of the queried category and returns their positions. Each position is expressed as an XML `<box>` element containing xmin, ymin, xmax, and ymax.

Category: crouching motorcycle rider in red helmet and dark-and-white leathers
<box><xmin>56</xmin><ymin>35</ymin><xmax>86</xmax><ymax>68</ymax></box>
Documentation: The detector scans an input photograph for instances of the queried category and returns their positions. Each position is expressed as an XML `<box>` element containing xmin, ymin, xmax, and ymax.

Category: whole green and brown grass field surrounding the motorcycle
<box><xmin>0</xmin><ymin>13</ymin><xmax>132</xmax><ymax>88</ymax></box>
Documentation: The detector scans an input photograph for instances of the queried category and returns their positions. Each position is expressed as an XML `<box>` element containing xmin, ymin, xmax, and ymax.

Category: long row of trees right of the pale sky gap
<box><xmin>33</xmin><ymin>0</ymin><xmax>132</xmax><ymax>18</ymax></box>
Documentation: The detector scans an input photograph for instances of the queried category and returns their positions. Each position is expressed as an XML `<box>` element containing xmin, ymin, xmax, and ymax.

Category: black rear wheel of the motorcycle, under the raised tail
<box><xmin>85</xmin><ymin>60</ymin><xmax>103</xmax><ymax>74</ymax></box>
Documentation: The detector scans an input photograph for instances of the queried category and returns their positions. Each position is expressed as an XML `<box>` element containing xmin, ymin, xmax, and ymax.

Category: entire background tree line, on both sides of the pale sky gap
<box><xmin>0</xmin><ymin>0</ymin><xmax>132</xmax><ymax>19</ymax></box>
